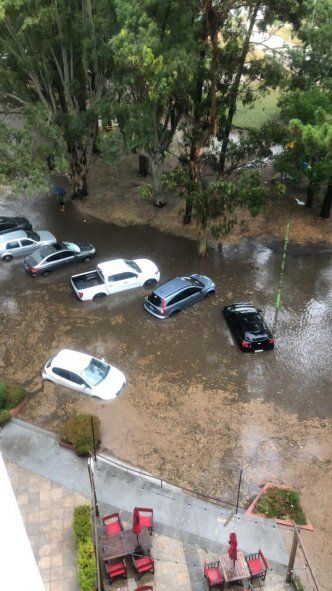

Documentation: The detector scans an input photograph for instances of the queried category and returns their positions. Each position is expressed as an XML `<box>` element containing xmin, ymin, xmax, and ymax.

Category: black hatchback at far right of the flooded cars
<box><xmin>223</xmin><ymin>303</ymin><xmax>274</xmax><ymax>352</ymax></box>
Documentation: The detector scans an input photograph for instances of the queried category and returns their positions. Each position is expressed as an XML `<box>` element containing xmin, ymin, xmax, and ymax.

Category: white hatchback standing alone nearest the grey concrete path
<box><xmin>42</xmin><ymin>349</ymin><xmax>126</xmax><ymax>400</ymax></box>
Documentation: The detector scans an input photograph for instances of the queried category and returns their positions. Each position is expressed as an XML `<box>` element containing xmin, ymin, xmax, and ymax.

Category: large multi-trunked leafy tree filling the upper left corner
<box><xmin>0</xmin><ymin>0</ymin><xmax>114</xmax><ymax>197</ymax></box>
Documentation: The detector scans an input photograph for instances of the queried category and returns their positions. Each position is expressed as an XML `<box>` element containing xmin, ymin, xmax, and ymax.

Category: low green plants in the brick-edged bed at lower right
<box><xmin>254</xmin><ymin>486</ymin><xmax>306</xmax><ymax>525</ymax></box>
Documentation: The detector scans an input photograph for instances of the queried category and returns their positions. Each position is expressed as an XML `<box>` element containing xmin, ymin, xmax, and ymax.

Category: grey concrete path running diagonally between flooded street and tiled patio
<box><xmin>0</xmin><ymin>419</ymin><xmax>287</xmax><ymax>565</ymax></box>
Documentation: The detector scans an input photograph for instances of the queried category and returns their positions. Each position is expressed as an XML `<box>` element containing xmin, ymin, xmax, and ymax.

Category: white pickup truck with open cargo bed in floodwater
<box><xmin>71</xmin><ymin>259</ymin><xmax>160</xmax><ymax>301</ymax></box>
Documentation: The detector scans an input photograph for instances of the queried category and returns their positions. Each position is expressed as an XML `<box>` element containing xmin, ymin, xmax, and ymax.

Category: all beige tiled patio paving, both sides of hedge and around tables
<box><xmin>5</xmin><ymin>459</ymin><xmax>292</xmax><ymax>591</ymax></box>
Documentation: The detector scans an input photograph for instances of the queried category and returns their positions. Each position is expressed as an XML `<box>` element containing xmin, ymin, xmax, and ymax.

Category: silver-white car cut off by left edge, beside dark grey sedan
<box><xmin>0</xmin><ymin>230</ymin><xmax>56</xmax><ymax>263</ymax></box>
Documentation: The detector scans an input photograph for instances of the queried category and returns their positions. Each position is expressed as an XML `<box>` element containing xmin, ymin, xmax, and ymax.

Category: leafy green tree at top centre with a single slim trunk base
<box><xmin>109</xmin><ymin>0</ymin><xmax>197</xmax><ymax>207</ymax></box>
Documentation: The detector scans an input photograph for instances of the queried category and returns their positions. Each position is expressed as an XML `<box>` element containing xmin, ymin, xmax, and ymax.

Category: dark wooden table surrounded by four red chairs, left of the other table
<box><xmin>101</xmin><ymin>527</ymin><xmax>152</xmax><ymax>561</ymax></box>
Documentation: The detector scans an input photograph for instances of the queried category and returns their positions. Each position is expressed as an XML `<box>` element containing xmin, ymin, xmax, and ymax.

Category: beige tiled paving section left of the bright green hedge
<box><xmin>5</xmin><ymin>460</ymin><xmax>89</xmax><ymax>591</ymax></box>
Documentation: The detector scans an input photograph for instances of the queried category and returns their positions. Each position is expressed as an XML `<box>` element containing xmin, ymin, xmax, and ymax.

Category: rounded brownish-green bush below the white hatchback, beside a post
<box><xmin>60</xmin><ymin>415</ymin><xmax>100</xmax><ymax>456</ymax></box>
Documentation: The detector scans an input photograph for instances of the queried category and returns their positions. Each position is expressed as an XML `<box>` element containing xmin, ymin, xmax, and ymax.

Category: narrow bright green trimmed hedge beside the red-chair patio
<box><xmin>73</xmin><ymin>505</ymin><xmax>97</xmax><ymax>591</ymax></box>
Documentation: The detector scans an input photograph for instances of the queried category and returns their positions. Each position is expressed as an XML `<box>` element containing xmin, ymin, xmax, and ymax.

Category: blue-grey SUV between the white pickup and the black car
<box><xmin>144</xmin><ymin>275</ymin><xmax>215</xmax><ymax>319</ymax></box>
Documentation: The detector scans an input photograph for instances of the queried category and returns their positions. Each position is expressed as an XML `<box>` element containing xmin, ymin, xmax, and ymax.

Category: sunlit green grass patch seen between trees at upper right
<box><xmin>233</xmin><ymin>90</ymin><xmax>280</xmax><ymax>129</ymax></box>
